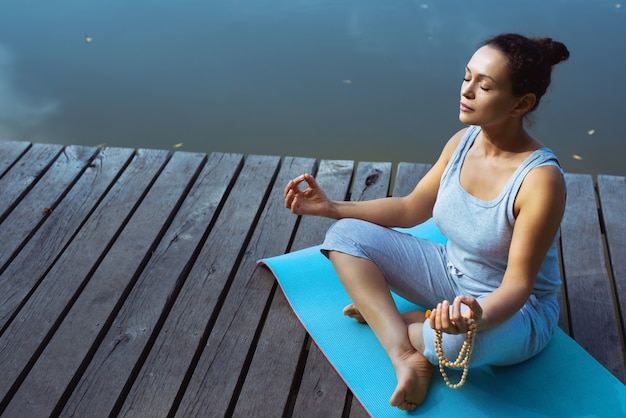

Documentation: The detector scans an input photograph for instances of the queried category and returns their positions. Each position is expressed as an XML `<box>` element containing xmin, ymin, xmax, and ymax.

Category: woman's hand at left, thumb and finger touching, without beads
<box><xmin>285</xmin><ymin>173</ymin><xmax>332</xmax><ymax>216</ymax></box>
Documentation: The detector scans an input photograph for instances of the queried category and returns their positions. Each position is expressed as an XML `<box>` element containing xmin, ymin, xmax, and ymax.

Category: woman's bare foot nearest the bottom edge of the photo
<box><xmin>389</xmin><ymin>351</ymin><xmax>435</xmax><ymax>411</ymax></box>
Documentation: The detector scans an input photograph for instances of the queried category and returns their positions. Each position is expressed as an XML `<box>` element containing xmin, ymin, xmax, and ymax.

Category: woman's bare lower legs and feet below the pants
<box><xmin>329</xmin><ymin>251</ymin><xmax>434</xmax><ymax>411</ymax></box>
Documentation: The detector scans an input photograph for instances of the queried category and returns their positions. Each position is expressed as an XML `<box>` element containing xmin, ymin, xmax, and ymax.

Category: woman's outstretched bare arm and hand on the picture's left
<box><xmin>285</xmin><ymin>130</ymin><xmax>465</xmax><ymax>227</ymax></box>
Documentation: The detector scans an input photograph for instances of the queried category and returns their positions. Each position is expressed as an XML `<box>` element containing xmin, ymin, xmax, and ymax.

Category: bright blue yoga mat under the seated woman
<box><xmin>260</xmin><ymin>221</ymin><xmax>626</xmax><ymax>417</ymax></box>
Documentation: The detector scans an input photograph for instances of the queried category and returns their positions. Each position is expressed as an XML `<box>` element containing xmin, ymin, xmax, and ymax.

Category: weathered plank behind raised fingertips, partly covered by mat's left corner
<box><xmin>176</xmin><ymin>157</ymin><xmax>316</xmax><ymax>417</ymax></box>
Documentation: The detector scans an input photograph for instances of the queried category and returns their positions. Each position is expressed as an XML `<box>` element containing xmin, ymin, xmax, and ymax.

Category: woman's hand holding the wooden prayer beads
<box><xmin>430</xmin><ymin>296</ymin><xmax>483</xmax><ymax>334</ymax></box>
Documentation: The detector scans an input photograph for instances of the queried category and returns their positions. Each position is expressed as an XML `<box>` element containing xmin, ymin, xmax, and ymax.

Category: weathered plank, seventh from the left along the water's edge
<box><xmin>61</xmin><ymin>154</ymin><xmax>243</xmax><ymax>417</ymax></box>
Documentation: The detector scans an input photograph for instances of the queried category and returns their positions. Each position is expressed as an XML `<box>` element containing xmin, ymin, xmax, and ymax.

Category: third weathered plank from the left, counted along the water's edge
<box><xmin>0</xmin><ymin>147</ymin><xmax>97</xmax><ymax>271</ymax></box>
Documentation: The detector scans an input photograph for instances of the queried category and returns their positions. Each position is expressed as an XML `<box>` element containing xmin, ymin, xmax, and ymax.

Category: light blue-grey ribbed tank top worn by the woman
<box><xmin>433</xmin><ymin>126</ymin><xmax>561</xmax><ymax>296</ymax></box>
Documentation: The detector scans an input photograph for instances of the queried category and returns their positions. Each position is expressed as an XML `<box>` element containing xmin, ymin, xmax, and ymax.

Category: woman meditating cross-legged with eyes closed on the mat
<box><xmin>285</xmin><ymin>34</ymin><xmax>569</xmax><ymax>410</ymax></box>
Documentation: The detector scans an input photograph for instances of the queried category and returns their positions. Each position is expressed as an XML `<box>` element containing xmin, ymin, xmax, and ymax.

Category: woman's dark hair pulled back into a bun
<box><xmin>482</xmin><ymin>33</ymin><xmax>569</xmax><ymax>111</ymax></box>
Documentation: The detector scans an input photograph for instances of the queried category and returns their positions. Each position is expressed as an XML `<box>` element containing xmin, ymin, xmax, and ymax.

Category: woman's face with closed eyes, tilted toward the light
<box><xmin>459</xmin><ymin>45</ymin><xmax>519</xmax><ymax>126</ymax></box>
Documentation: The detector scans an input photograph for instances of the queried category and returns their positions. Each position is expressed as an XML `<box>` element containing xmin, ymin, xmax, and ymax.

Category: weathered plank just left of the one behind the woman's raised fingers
<box><xmin>119</xmin><ymin>156</ymin><xmax>279</xmax><ymax>416</ymax></box>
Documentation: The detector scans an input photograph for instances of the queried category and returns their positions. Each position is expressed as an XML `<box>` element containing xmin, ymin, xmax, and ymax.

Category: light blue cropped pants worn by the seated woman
<box><xmin>322</xmin><ymin>219</ymin><xmax>559</xmax><ymax>367</ymax></box>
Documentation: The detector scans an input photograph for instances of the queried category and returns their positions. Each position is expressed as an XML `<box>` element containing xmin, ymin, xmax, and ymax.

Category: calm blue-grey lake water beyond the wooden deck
<box><xmin>0</xmin><ymin>0</ymin><xmax>626</xmax><ymax>175</ymax></box>
